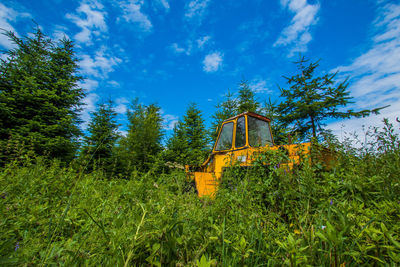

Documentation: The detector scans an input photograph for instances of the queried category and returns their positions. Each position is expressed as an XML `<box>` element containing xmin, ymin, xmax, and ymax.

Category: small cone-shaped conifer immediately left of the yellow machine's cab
<box><xmin>165</xmin><ymin>103</ymin><xmax>208</xmax><ymax>165</ymax></box>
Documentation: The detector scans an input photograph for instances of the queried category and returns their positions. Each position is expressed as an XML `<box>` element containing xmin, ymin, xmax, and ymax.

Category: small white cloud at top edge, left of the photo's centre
<box><xmin>120</xmin><ymin>0</ymin><xmax>152</xmax><ymax>32</ymax></box>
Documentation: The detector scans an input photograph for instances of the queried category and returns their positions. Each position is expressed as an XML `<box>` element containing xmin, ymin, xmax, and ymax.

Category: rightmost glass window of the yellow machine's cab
<box><xmin>247</xmin><ymin>116</ymin><xmax>273</xmax><ymax>147</ymax></box>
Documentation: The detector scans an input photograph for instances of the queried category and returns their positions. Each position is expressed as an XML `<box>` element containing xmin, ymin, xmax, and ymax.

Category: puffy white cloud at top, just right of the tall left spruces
<box><xmin>66</xmin><ymin>1</ymin><xmax>108</xmax><ymax>44</ymax></box>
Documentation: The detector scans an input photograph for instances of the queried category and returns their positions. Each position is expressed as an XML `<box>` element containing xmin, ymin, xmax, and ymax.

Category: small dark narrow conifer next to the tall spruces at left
<box><xmin>82</xmin><ymin>100</ymin><xmax>119</xmax><ymax>172</ymax></box>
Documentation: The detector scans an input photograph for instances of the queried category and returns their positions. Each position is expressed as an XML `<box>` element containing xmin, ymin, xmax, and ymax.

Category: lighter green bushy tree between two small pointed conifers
<box><xmin>116</xmin><ymin>99</ymin><xmax>163</xmax><ymax>172</ymax></box>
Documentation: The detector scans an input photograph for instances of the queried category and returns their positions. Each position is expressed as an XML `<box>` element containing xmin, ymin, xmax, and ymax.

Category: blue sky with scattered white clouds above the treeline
<box><xmin>0</xmin><ymin>0</ymin><xmax>400</xmax><ymax>141</ymax></box>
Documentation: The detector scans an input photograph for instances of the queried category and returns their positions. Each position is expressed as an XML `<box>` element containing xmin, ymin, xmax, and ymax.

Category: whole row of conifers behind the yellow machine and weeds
<box><xmin>0</xmin><ymin>28</ymin><xmax>379</xmax><ymax>176</ymax></box>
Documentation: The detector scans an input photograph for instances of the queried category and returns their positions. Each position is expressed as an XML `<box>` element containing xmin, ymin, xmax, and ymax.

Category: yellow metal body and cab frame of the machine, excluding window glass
<box><xmin>186</xmin><ymin>112</ymin><xmax>311</xmax><ymax>197</ymax></box>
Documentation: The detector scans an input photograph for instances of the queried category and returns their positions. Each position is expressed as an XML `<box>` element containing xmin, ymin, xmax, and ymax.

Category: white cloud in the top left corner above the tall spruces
<box><xmin>0</xmin><ymin>3</ymin><xmax>31</xmax><ymax>49</ymax></box>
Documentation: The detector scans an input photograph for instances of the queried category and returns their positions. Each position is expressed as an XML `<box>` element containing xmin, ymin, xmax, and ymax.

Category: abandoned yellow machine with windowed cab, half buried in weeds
<box><xmin>185</xmin><ymin>112</ymin><xmax>311</xmax><ymax>197</ymax></box>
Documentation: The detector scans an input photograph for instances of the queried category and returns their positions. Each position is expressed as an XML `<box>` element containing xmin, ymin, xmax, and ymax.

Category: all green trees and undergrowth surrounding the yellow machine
<box><xmin>0</xmin><ymin>26</ymin><xmax>400</xmax><ymax>266</ymax></box>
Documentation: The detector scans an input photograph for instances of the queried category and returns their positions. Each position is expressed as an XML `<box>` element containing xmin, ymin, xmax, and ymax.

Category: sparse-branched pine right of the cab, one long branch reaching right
<box><xmin>278</xmin><ymin>57</ymin><xmax>382</xmax><ymax>139</ymax></box>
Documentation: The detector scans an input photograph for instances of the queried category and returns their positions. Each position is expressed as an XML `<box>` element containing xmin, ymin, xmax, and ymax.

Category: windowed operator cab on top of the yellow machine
<box><xmin>213</xmin><ymin>112</ymin><xmax>274</xmax><ymax>152</ymax></box>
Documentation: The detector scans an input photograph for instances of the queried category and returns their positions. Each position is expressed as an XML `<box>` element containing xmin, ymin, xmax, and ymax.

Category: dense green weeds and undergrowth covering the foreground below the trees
<box><xmin>0</xmin><ymin>120</ymin><xmax>400</xmax><ymax>266</ymax></box>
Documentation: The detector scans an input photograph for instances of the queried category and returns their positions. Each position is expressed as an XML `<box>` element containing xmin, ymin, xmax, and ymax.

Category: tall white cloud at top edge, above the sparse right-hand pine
<box><xmin>274</xmin><ymin>0</ymin><xmax>320</xmax><ymax>56</ymax></box>
